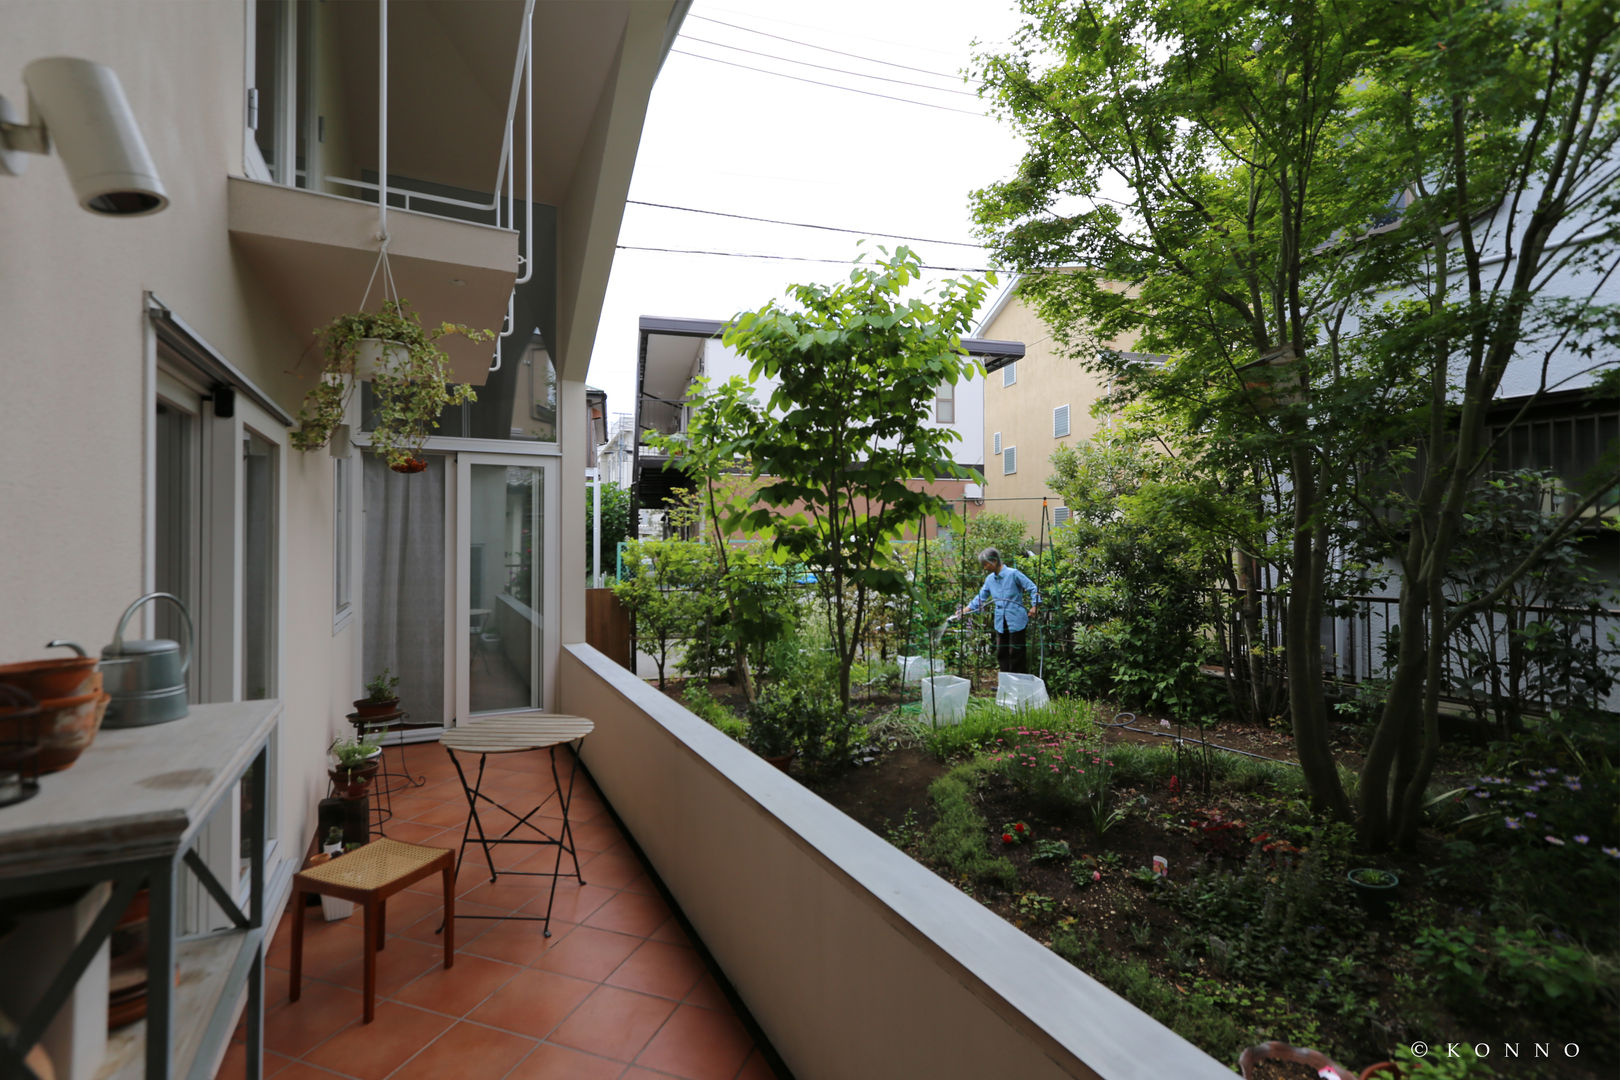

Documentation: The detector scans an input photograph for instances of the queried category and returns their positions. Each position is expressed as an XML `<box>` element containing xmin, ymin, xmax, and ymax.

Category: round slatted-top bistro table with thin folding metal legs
<box><xmin>439</xmin><ymin>712</ymin><xmax>596</xmax><ymax>938</ymax></box>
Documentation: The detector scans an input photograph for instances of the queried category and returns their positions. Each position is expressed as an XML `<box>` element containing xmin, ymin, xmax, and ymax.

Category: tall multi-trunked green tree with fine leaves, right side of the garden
<box><xmin>977</xmin><ymin>0</ymin><xmax>1620</xmax><ymax>847</ymax></box>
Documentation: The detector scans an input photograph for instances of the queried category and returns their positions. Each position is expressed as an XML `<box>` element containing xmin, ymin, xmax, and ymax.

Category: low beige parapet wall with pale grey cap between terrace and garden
<box><xmin>557</xmin><ymin>644</ymin><xmax>1233</xmax><ymax>1080</ymax></box>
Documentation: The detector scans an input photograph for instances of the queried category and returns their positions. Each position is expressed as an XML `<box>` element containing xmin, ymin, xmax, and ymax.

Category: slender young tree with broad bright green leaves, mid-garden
<box><xmin>723</xmin><ymin>248</ymin><xmax>995</xmax><ymax>709</ymax></box>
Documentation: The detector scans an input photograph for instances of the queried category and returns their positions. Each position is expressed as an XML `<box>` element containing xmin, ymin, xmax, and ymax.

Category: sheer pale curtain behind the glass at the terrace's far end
<box><xmin>361</xmin><ymin>453</ymin><xmax>446</xmax><ymax>724</ymax></box>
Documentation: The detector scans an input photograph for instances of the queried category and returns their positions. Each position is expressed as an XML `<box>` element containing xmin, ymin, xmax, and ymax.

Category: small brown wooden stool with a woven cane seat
<box><xmin>288</xmin><ymin>837</ymin><xmax>455</xmax><ymax>1023</ymax></box>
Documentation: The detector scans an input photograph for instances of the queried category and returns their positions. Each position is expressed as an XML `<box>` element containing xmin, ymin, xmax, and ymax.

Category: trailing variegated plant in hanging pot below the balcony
<box><xmin>292</xmin><ymin>300</ymin><xmax>494</xmax><ymax>473</ymax></box>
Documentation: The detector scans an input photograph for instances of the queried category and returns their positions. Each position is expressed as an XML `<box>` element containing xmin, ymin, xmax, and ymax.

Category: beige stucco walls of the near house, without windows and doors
<box><xmin>0</xmin><ymin>0</ymin><xmax>670</xmax><ymax>1075</ymax></box>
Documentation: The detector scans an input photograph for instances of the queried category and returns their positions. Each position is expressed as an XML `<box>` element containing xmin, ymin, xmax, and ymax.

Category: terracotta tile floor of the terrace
<box><xmin>219</xmin><ymin>743</ymin><xmax>776</xmax><ymax>1080</ymax></box>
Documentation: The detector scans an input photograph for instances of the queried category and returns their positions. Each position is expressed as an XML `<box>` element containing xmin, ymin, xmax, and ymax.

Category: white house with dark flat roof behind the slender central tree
<box><xmin>635</xmin><ymin>316</ymin><xmax>1024</xmax><ymax>534</ymax></box>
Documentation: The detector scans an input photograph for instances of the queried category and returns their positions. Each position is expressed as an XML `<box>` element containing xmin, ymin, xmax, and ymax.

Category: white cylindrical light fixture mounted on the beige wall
<box><xmin>0</xmin><ymin>57</ymin><xmax>168</xmax><ymax>217</ymax></box>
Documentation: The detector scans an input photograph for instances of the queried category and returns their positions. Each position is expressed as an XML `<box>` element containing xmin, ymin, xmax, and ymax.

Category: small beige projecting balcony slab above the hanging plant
<box><xmin>228</xmin><ymin>176</ymin><xmax>517</xmax><ymax>385</ymax></box>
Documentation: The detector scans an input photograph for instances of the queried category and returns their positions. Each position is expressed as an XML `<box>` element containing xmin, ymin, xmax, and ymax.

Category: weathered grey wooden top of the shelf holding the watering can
<box><xmin>0</xmin><ymin>701</ymin><xmax>282</xmax><ymax>879</ymax></box>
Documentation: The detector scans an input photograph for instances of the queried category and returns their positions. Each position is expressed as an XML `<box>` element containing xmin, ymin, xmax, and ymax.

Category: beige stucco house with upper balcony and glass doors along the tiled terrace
<box><xmin>0</xmin><ymin>0</ymin><xmax>687</xmax><ymax>1075</ymax></box>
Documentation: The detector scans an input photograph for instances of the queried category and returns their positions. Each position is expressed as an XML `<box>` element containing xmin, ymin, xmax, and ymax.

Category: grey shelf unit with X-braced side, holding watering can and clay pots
<box><xmin>0</xmin><ymin>701</ymin><xmax>282</xmax><ymax>1080</ymax></box>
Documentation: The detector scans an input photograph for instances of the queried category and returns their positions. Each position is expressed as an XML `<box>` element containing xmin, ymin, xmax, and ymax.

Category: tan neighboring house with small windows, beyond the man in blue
<box><xmin>978</xmin><ymin>275</ymin><xmax>1155</xmax><ymax>539</ymax></box>
